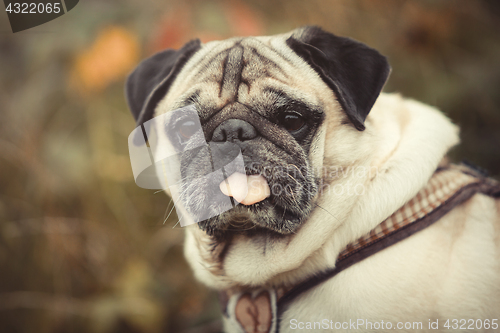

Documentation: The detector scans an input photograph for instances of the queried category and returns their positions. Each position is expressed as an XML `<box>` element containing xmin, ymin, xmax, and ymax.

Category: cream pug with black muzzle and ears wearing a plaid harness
<box><xmin>126</xmin><ymin>27</ymin><xmax>500</xmax><ymax>332</ymax></box>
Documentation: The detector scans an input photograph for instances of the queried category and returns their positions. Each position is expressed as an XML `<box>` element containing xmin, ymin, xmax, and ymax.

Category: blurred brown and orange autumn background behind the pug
<box><xmin>0</xmin><ymin>0</ymin><xmax>500</xmax><ymax>333</ymax></box>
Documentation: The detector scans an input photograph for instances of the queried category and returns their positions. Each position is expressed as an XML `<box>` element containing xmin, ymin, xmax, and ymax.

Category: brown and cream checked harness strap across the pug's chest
<box><xmin>219</xmin><ymin>164</ymin><xmax>500</xmax><ymax>333</ymax></box>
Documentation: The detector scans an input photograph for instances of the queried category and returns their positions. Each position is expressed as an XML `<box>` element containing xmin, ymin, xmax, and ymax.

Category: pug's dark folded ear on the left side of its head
<box><xmin>125</xmin><ymin>39</ymin><xmax>200</xmax><ymax>125</ymax></box>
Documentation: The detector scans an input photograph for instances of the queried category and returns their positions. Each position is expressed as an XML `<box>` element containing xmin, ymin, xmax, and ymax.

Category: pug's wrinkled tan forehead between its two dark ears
<box><xmin>156</xmin><ymin>35</ymin><xmax>335</xmax><ymax>115</ymax></box>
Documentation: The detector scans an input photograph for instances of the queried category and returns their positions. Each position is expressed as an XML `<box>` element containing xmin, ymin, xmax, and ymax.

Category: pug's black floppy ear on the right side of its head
<box><xmin>286</xmin><ymin>26</ymin><xmax>391</xmax><ymax>131</ymax></box>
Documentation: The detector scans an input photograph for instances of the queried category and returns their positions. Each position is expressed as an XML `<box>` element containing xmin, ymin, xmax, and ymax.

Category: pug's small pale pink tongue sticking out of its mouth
<box><xmin>219</xmin><ymin>172</ymin><xmax>271</xmax><ymax>206</ymax></box>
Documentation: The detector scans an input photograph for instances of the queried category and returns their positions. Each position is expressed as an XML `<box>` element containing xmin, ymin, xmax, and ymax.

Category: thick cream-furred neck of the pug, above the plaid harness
<box><xmin>182</xmin><ymin>94</ymin><xmax>458</xmax><ymax>289</ymax></box>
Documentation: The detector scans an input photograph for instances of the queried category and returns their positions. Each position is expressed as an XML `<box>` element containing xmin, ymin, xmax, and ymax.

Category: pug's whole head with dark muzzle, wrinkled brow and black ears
<box><xmin>127</xmin><ymin>27</ymin><xmax>389</xmax><ymax>237</ymax></box>
